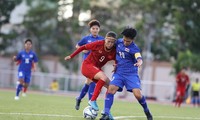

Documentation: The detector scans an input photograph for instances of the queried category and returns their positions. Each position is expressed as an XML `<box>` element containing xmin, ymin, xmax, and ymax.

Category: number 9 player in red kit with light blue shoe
<box><xmin>65</xmin><ymin>31</ymin><xmax>117</xmax><ymax>111</ymax></box>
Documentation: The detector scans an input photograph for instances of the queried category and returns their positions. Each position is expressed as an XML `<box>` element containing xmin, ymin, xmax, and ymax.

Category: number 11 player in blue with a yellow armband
<box><xmin>100</xmin><ymin>27</ymin><xmax>153</xmax><ymax>120</ymax></box>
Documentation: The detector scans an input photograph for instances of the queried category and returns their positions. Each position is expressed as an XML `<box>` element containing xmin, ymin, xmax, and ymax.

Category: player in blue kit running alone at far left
<box><xmin>13</xmin><ymin>39</ymin><xmax>38</xmax><ymax>100</ymax></box>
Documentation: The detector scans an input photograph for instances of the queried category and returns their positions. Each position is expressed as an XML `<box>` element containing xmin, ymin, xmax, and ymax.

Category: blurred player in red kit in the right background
<box><xmin>175</xmin><ymin>68</ymin><xmax>190</xmax><ymax>107</ymax></box>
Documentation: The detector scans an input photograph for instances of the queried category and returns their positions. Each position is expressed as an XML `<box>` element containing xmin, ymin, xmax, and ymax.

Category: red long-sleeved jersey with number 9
<box><xmin>70</xmin><ymin>40</ymin><xmax>116</xmax><ymax>68</ymax></box>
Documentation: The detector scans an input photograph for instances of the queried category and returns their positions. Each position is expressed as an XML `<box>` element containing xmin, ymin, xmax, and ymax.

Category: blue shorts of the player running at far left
<box><xmin>18</xmin><ymin>71</ymin><xmax>31</xmax><ymax>83</ymax></box>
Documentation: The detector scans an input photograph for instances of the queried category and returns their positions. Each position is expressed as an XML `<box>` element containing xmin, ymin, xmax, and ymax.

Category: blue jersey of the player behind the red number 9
<box><xmin>77</xmin><ymin>34</ymin><xmax>104</xmax><ymax>59</ymax></box>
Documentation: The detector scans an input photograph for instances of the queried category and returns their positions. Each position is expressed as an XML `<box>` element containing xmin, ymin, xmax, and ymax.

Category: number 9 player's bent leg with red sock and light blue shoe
<box><xmin>88</xmin><ymin>71</ymin><xmax>110</xmax><ymax>111</ymax></box>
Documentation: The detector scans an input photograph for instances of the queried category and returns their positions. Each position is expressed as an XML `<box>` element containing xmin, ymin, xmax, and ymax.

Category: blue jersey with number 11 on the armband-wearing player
<box><xmin>116</xmin><ymin>38</ymin><xmax>140</xmax><ymax>74</ymax></box>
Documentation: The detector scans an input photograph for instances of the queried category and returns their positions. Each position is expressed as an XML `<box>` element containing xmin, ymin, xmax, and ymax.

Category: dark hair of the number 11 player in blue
<box><xmin>121</xmin><ymin>26</ymin><xmax>137</xmax><ymax>39</ymax></box>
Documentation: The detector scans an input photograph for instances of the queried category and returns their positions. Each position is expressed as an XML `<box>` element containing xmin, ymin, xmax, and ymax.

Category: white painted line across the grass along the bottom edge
<box><xmin>0</xmin><ymin>112</ymin><xmax>200</xmax><ymax>120</ymax></box>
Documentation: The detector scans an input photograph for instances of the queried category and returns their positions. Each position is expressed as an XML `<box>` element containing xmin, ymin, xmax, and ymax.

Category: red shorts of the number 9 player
<box><xmin>81</xmin><ymin>62</ymin><xmax>101</xmax><ymax>82</ymax></box>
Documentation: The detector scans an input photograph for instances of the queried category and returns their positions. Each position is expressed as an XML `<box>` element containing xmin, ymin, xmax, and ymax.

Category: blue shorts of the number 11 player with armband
<box><xmin>110</xmin><ymin>73</ymin><xmax>141</xmax><ymax>92</ymax></box>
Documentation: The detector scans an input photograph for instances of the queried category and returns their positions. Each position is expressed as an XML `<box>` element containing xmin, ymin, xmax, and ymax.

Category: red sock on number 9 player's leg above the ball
<box><xmin>91</xmin><ymin>79</ymin><xmax>105</xmax><ymax>101</ymax></box>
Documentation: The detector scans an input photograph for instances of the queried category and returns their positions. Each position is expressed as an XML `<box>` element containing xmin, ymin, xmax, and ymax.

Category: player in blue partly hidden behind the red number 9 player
<box><xmin>75</xmin><ymin>20</ymin><xmax>104</xmax><ymax>110</ymax></box>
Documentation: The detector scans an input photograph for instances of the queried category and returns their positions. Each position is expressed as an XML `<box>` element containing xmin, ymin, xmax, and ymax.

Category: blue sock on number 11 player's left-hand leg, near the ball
<box><xmin>104</xmin><ymin>93</ymin><xmax>114</xmax><ymax>115</ymax></box>
